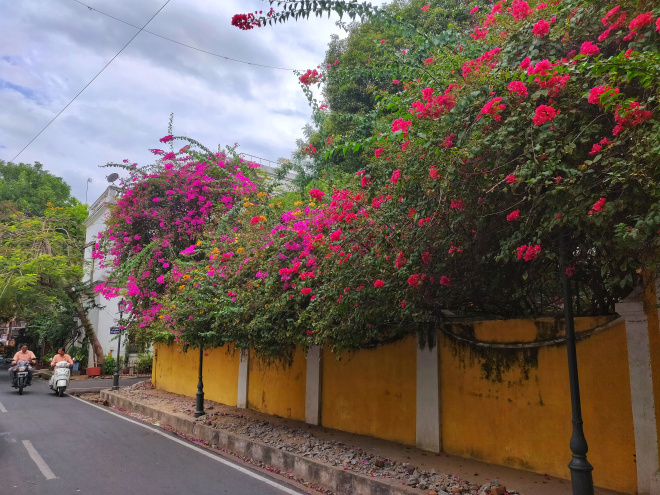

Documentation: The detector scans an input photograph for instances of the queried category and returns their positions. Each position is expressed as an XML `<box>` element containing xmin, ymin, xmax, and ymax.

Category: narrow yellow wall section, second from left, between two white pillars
<box><xmin>248</xmin><ymin>349</ymin><xmax>307</xmax><ymax>421</ymax></box>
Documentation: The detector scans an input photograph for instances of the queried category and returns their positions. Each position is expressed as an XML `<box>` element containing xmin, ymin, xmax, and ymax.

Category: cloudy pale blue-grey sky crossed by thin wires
<box><xmin>0</xmin><ymin>0</ymin><xmax>384</xmax><ymax>204</ymax></box>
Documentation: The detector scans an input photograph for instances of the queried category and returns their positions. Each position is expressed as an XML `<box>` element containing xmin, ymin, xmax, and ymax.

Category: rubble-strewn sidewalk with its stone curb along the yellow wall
<box><xmin>86</xmin><ymin>382</ymin><xmax>621</xmax><ymax>495</ymax></box>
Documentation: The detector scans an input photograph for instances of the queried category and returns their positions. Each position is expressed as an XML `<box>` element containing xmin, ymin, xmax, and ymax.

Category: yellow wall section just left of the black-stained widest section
<box><xmin>321</xmin><ymin>336</ymin><xmax>417</xmax><ymax>445</ymax></box>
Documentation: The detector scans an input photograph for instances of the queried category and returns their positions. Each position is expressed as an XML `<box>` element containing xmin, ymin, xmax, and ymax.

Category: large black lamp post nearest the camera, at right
<box><xmin>559</xmin><ymin>233</ymin><xmax>594</xmax><ymax>495</ymax></box>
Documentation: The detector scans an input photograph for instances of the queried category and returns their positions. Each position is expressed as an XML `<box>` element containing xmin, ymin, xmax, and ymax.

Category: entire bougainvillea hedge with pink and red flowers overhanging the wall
<box><xmin>99</xmin><ymin>0</ymin><xmax>660</xmax><ymax>354</ymax></box>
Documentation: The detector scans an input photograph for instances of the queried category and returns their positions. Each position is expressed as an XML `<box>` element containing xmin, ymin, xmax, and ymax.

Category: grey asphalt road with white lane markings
<box><xmin>0</xmin><ymin>369</ymin><xmax>304</xmax><ymax>495</ymax></box>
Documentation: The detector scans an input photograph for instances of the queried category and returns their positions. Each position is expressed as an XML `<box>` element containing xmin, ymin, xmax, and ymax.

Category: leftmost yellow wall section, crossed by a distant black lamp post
<box><xmin>151</xmin><ymin>344</ymin><xmax>241</xmax><ymax>406</ymax></box>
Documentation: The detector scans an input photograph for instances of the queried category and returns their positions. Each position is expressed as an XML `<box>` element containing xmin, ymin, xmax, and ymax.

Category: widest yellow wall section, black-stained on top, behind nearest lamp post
<box><xmin>439</xmin><ymin>318</ymin><xmax>637</xmax><ymax>493</ymax></box>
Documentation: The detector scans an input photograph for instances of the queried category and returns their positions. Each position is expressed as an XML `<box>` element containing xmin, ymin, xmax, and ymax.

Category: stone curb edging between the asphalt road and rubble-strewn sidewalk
<box><xmin>100</xmin><ymin>390</ymin><xmax>422</xmax><ymax>495</ymax></box>
